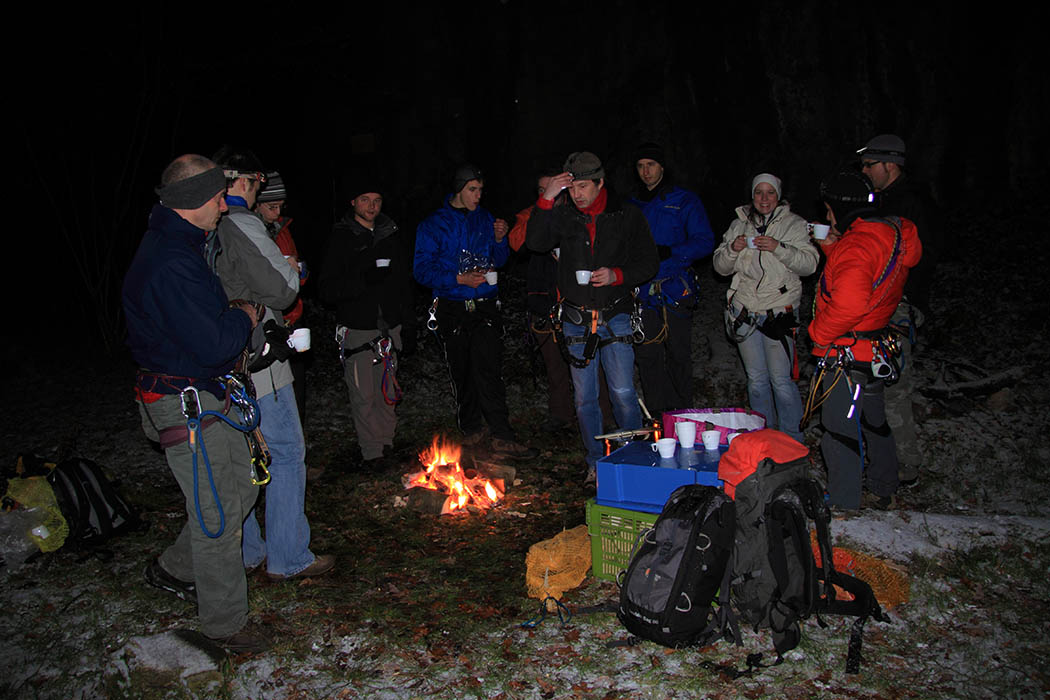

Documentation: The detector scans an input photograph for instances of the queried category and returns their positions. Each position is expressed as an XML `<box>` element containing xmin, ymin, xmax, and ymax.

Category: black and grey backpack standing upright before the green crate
<box><xmin>616</xmin><ymin>484</ymin><xmax>735</xmax><ymax>648</ymax></box>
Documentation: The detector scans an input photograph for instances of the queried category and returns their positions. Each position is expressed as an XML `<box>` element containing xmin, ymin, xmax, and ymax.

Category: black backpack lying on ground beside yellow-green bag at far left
<box><xmin>47</xmin><ymin>458</ymin><xmax>148</xmax><ymax>551</ymax></box>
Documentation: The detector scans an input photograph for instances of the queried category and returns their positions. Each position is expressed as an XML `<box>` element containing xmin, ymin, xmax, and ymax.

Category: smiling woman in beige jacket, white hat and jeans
<box><xmin>713</xmin><ymin>173</ymin><xmax>819</xmax><ymax>442</ymax></box>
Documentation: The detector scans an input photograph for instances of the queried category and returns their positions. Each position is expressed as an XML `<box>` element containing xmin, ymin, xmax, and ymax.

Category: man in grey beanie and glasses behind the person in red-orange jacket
<box><xmin>857</xmin><ymin>133</ymin><xmax>941</xmax><ymax>486</ymax></box>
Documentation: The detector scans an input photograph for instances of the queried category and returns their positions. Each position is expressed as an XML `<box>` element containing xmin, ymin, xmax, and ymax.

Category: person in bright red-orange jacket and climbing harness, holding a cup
<box><xmin>810</xmin><ymin>171</ymin><xmax>922</xmax><ymax>509</ymax></box>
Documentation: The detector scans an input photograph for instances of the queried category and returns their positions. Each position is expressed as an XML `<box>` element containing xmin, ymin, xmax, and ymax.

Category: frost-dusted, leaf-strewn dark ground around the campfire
<box><xmin>0</xmin><ymin>205</ymin><xmax>1050</xmax><ymax>698</ymax></box>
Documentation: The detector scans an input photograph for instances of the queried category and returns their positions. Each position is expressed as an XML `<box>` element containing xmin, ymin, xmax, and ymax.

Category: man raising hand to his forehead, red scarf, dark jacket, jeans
<box><xmin>525</xmin><ymin>151</ymin><xmax>659</xmax><ymax>481</ymax></box>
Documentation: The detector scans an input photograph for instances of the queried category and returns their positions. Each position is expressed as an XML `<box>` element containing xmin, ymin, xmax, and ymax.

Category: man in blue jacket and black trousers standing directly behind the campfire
<box><xmin>413</xmin><ymin>165</ymin><xmax>538</xmax><ymax>458</ymax></box>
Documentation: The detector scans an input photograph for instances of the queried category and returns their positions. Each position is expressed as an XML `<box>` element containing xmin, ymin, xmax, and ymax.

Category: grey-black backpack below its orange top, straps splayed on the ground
<box><xmin>723</xmin><ymin>431</ymin><xmax>887</xmax><ymax>673</ymax></box>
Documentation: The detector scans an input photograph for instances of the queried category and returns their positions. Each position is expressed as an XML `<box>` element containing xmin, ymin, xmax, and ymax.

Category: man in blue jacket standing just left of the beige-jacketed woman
<box><xmin>631</xmin><ymin>143</ymin><xmax>715</xmax><ymax>418</ymax></box>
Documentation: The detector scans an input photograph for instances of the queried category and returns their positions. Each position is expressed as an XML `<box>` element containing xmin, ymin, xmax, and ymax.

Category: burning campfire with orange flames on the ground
<box><xmin>401</xmin><ymin>436</ymin><xmax>506</xmax><ymax>515</ymax></box>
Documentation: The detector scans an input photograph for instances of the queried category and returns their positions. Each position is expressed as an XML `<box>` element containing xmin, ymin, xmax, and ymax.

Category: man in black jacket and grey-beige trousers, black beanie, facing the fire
<box><xmin>319</xmin><ymin>177</ymin><xmax>412</xmax><ymax>467</ymax></box>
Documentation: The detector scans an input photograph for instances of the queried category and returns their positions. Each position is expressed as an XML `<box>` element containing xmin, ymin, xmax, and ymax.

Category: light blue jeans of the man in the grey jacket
<box><xmin>243</xmin><ymin>384</ymin><xmax>316</xmax><ymax>576</ymax></box>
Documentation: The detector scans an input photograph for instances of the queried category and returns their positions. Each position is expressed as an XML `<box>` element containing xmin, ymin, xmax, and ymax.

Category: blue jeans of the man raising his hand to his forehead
<box><xmin>564</xmin><ymin>314</ymin><xmax>642</xmax><ymax>467</ymax></box>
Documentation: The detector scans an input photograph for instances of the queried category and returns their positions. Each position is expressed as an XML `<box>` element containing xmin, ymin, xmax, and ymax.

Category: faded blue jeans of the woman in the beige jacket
<box><xmin>737</xmin><ymin>310</ymin><xmax>802</xmax><ymax>442</ymax></box>
